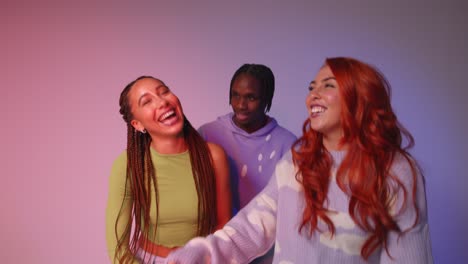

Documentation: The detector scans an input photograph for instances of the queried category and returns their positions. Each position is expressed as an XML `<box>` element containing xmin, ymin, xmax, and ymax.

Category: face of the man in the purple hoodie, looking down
<box><xmin>230</xmin><ymin>74</ymin><xmax>267</xmax><ymax>133</ymax></box>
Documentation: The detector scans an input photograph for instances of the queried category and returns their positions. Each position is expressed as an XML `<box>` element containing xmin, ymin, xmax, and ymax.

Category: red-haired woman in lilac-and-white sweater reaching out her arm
<box><xmin>167</xmin><ymin>57</ymin><xmax>433</xmax><ymax>263</ymax></box>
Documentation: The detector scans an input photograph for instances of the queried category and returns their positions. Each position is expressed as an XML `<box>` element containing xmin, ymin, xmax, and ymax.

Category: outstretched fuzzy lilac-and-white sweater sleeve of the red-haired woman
<box><xmin>166</xmin><ymin>164</ymin><xmax>278</xmax><ymax>264</ymax></box>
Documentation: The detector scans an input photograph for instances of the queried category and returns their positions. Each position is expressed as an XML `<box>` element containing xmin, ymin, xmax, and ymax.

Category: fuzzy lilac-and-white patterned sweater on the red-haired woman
<box><xmin>166</xmin><ymin>151</ymin><xmax>433</xmax><ymax>264</ymax></box>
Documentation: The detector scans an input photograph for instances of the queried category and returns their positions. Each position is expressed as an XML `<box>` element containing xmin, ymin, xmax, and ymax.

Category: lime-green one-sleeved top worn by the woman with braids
<box><xmin>106</xmin><ymin>148</ymin><xmax>198</xmax><ymax>259</ymax></box>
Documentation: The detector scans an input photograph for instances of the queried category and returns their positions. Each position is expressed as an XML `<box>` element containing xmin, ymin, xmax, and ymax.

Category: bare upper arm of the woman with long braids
<box><xmin>208</xmin><ymin>143</ymin><xmax>232</xmax><ymax>230</ymax></box>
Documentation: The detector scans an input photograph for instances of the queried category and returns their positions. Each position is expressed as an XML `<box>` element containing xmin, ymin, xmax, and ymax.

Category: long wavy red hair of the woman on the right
<box><xmin>292</xmin><ymin>57</ymin><xmax>419</xmax><ymax>259</ymax></box>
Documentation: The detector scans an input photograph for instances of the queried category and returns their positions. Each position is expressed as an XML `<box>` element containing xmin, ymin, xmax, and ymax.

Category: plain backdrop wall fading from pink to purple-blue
<box><xmin>0</xmin><ymin>0</ymin><xmax>468</xmax><ymax>263</ymax></box>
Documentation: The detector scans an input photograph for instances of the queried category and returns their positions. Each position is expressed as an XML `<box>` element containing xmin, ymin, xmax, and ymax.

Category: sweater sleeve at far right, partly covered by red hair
<box><xmin>380</xmin><ymin>157</ymin><xmax>433</xmax><ymax>264</ymax></box>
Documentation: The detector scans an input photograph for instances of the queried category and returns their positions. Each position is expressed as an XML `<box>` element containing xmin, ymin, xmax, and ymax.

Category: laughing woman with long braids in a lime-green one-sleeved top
<box><xmin>106</xmin><ymin>76</ymin><xmax>231</xmax><ymax>263</ymax></box>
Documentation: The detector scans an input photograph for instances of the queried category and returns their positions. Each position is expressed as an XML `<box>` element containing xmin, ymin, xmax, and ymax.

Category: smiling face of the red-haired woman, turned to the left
<box><xmin>306</xmin><ymin>66</ymin><xmax>343</xmax><ymax>150</ymax></box>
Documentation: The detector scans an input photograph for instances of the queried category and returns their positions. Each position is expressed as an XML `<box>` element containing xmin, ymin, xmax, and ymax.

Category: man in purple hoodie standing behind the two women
<box><xmin>199</xmin><ymin>64</ymin><xmax>296</xmax><ymax>263</ymax></box>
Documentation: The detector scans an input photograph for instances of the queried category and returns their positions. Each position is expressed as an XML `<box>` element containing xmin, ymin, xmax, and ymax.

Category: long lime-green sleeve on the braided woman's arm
<box><xmin>106</xmin><ymin>153</ymin><xmax>138</xmax><ymax>263</ymax></box>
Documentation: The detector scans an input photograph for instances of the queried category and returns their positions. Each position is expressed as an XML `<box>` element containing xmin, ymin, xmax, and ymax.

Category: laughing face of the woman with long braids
<box><xmin>128</xmin><ymin>78</ymin><xmax>184</xmax><ymax>139</ymax></box>
